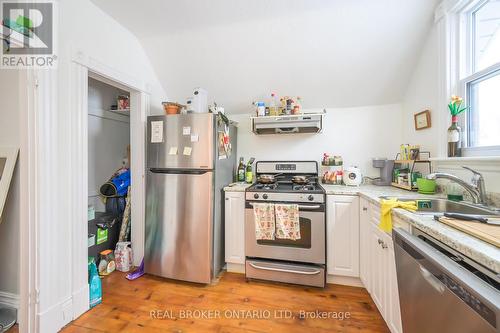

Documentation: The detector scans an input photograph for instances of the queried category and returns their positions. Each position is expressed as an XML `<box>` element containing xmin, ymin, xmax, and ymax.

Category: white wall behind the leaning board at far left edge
<box><xmin>0</xmin><ymin>70</ymin><xmax>20</xmax><ymax>303</ymax></box>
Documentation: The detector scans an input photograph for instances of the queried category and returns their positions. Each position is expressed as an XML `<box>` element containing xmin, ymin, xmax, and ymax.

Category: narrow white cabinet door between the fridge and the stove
<box><xmin>225</xmin><ymin>192</ymin><xmax>245</xmax><ymax>264</ymax></box>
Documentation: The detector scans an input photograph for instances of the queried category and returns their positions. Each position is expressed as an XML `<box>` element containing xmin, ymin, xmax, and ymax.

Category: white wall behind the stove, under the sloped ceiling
<box><xmin>229</xmin><ymin>104</ymin><xmax>403</xmax><ymax>176</ymax></box>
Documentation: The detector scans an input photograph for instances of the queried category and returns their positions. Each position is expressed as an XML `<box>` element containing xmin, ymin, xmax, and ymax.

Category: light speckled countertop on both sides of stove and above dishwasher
<box><xmin>224</xmin><ymin>183</ymin><xmax>500</xmax><ymax>274</ymax></box>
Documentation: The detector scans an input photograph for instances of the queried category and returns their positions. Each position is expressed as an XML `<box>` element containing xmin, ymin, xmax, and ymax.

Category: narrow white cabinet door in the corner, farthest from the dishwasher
<box><xmin>359</xmin><ymin>198</ymin><xmax>371</xmax><ymax>292</ymax></box>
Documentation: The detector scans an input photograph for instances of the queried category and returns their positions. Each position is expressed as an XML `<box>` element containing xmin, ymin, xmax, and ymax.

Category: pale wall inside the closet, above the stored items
<box><xmin>88</xmin><ymin>79</ymin><xmax>130</xmax><ymax>212</ymax></box>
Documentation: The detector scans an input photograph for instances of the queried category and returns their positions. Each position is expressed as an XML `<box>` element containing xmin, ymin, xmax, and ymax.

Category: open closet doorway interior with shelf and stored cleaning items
<box><xmin>87</xmin><ymin>77</ymin><xmax>131</xmax><ymax>273</ymax></box>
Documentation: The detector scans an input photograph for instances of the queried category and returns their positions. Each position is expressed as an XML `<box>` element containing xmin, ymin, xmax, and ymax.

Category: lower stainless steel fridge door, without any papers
<box><xmin>144</xmin><ymin>170</ymin><xmax>213</xmax><ymax>283</ymax></box>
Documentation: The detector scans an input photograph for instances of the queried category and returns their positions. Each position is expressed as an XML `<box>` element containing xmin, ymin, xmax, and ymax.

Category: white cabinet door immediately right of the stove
<box><xmin>326</xmin><ymin>195</ymin><xmax>359</xmax><ymax>277</ymax></box>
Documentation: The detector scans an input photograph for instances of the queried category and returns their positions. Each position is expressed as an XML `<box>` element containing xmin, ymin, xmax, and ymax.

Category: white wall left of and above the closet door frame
<box><xmin>37</xmin><ymin>0</ymin><xmax>165</xmax><ymax>332</ymax></box>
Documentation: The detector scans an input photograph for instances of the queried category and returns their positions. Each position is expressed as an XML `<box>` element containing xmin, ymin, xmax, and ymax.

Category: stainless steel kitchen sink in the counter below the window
<box><xmin>380</xmin><ymin>196</ymin><xmax>500</xmax><ymax>216</ymax></box>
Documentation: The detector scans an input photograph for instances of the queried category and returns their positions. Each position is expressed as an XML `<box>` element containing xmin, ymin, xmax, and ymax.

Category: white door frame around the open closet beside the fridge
<box><xmin>69</xmin><ymin>51</ymin><xmax>150</xmax><ymax>319</ymax></box>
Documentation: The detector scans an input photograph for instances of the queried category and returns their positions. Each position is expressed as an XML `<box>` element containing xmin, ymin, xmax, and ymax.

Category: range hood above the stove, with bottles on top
<box><xmin>252</xmin><ymin>113</ymin><xmax>325</xmax><ymax>134</ymax></box>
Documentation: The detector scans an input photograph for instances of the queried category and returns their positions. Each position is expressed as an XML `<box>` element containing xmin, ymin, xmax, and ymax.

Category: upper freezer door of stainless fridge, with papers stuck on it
<box><xmin>147</xmin><ymin>113</ymin><xmax>215</xmax><ymax>169</ymax></box>
